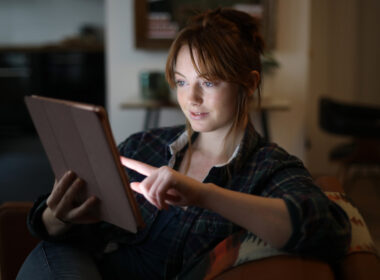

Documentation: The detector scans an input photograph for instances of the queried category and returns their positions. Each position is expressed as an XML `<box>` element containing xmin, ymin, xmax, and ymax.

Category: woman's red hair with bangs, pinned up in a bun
<box><xmin>166</xmin><ymin>8</ymin><xmax>264</xmax><ymax>166</ymax></box>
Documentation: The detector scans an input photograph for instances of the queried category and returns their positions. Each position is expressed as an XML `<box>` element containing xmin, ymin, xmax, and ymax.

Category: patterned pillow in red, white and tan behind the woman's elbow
<box><xmin>178</xmin><ymin>192</ymin><xmax>377</xmax><ymax>280</ymax></box>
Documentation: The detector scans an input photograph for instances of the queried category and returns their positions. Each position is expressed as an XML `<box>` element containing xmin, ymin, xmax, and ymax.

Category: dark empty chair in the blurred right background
<box><xmin>319</xmin><ymin>97</ymin><xmax>380</xmax><ymax>185</ymax></box>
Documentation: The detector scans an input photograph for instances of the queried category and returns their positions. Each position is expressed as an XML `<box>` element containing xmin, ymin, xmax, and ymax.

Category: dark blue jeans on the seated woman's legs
<box><xmin>16</xmin><ymin>241</ymin><xmax>165</xmax><ymax>280</ymax></box>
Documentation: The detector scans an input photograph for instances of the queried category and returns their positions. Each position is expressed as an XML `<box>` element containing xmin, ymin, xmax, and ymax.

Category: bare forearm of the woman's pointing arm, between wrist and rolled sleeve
<box><xmin>200</xmin><ymin>184</ymin><xmax>292</xmax><ymax>248</ymax></box>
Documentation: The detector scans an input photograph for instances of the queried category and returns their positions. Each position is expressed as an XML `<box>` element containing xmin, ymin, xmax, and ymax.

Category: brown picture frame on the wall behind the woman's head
<box><xmin>134</xmin><ymin>0</ymin><xmax>277</xmax><ymax>51</ymax></box>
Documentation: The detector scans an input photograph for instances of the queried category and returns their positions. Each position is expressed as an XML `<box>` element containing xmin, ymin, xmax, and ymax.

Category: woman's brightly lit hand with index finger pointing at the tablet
<box><xmin>120</xmin><ymin>156</ymin><xmax>208</xmax><ymax>209</ymax></box>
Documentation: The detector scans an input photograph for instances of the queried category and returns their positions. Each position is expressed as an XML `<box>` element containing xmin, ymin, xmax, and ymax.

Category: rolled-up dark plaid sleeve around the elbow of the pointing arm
<box><xmin>265</xmin><ymin>163</ymin><xmax>351</xmax><ymax>260</ymax></box>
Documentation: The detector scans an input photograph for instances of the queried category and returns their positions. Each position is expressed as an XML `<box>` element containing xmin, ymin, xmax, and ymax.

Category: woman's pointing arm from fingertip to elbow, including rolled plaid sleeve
<box><xmin>121</xmin><ymin>157</ymin><xmax>351</xmax><ymax>259</ymax></box>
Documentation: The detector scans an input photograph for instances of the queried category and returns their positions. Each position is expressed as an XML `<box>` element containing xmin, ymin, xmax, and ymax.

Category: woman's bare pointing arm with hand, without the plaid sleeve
<box><xmin>121</xmin><ymin>157</ymin><xmax>292</xmax><ymax>247</ymax></box>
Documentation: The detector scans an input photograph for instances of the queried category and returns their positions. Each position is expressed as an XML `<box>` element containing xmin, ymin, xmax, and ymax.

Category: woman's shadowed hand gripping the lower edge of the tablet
<box><xmin>46</xmin><ymin>171</ymin><xmax>100</xmax><ymax>224</ymax></box>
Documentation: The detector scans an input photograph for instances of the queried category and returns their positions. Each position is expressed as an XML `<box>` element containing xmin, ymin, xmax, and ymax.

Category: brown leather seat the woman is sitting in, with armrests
<box><xmin>0</xmin><ymin>177</ymin><xmax>380</xmax><ymax>280</ymax></box>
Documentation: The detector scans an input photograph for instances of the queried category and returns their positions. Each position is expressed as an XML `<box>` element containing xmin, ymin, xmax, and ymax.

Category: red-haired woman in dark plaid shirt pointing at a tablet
<box><xmin>18</xmin><ymin>9</ymin><xmax>350</xmax><ymax>279</ymax></box>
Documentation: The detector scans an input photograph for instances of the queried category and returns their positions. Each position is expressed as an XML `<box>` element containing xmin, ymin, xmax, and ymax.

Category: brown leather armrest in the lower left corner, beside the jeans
<box><xmin>0</xmin><ymin>202</ymin><xmax>38</xmax><ymax>280</ymax></box>
